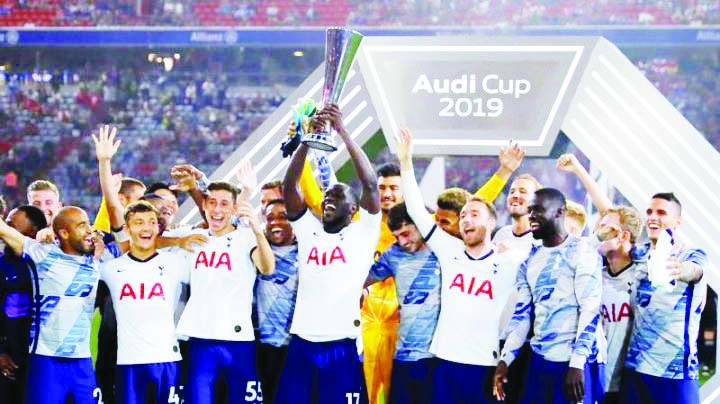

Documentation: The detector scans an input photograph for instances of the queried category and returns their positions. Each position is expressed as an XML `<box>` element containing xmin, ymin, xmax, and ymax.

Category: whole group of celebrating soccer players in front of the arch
<box><xmin>0</xmin><ymin>105</ymin><xmax>708</xmax><ymax>404</ymax></box>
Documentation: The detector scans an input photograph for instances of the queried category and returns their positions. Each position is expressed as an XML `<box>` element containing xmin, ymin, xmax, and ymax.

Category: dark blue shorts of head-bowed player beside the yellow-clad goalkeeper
<box><xmin>390</xmin><ymin>358</ymin><xmax>437</xmax><ymax>404</ymax></box>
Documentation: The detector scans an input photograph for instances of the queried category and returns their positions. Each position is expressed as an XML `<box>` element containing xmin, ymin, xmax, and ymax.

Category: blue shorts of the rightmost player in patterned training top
<box><xmin>620</xmin><ymin>369</ymin><xmax>700</xmax><ymax>404</ymax></box>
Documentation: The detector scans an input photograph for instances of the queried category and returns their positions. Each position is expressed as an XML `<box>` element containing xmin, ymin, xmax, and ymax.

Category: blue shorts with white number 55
<box><xmin>185</xmin><ymin>338</ymin><xmax>262</xmax><ymax>404</ymax></box>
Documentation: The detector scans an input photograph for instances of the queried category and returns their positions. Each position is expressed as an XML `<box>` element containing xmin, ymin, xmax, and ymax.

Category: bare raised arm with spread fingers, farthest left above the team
<box><xmin>92</xmin><ymin>125</ymin><xmax>125</xmax><ymax>230</ymax></box>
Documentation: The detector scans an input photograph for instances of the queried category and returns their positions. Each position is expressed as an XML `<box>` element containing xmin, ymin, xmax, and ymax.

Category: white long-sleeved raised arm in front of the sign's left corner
<box><xmin>396</xmin><ymin>128</ymin><xmax>435</xmax><ymax>239</ymax></box>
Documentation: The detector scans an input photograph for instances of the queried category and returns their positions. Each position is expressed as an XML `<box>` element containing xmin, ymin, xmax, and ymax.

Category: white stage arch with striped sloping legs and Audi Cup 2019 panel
<box><xmin>179</xmin><ymin>36</ymin><xmax>720</xmax><ymax>403</ymax></box>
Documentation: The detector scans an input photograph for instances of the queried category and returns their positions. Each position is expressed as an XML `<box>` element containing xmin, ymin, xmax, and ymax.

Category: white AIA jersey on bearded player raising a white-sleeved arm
<box><xmin>428</xmin><ymin>228</ymin><xmax>519</xmax><ymax>366</ymax></box>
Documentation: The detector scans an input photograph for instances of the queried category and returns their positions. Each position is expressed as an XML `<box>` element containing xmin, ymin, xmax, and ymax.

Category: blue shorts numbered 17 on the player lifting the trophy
<box><xmin>275</xmin><ymin>335</ymin><xmax>362</xmax><ymax>404</ymax></box>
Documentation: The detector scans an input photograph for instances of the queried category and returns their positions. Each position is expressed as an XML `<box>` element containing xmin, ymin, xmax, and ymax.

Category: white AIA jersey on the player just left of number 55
<box><xmin>100</xmin><ymin>251</ymin><xmax>190</xmax><ymax>365</ymax></box>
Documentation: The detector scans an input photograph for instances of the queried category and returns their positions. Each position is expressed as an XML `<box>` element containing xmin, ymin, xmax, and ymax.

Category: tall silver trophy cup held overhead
<box><xmin>302</xmin><ymin>28</ymin><xmax>362</xmax><ymax>152</ymax></box>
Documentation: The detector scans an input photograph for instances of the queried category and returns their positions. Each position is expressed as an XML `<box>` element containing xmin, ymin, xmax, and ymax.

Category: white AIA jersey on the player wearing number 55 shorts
<box><xmin>178</xmin><ymin>227</ymin><xmax>257</xmax><ymax>341</ymax></box>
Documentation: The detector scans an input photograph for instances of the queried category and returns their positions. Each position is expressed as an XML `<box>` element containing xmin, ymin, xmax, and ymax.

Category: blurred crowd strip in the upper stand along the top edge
<box><xmin>0</xmin><ymin>0</ymin><xmax>720</xmax><ymax>26</ymax></box>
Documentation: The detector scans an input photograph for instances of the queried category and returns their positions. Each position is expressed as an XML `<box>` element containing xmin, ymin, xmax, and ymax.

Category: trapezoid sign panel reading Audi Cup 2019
<box><xmin>358</xmin><ymin>37</ymin><xmax>597</xmax><ymax>155</ymax></box>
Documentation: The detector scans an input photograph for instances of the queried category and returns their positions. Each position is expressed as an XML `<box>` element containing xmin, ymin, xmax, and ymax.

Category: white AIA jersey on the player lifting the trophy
<box><xmin>290</xmin><ymin>209</ymin><xmax>382</xmax><ymax>342</ymax></box>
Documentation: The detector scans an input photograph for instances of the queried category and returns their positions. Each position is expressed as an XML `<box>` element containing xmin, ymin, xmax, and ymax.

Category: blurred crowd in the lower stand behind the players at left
<box><xmin>0</xmin><ymin>58</ymin><xmax>289</xmax><ymax>216</ymax></box>
